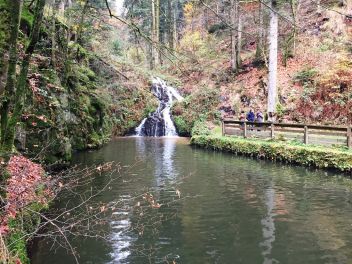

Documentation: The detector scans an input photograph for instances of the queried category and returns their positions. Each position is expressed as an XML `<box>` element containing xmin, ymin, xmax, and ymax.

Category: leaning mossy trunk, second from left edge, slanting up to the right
<box><xmin>1</xmin><ymin>0</ymin><xmax>45</xmax><ymax>152</ymax></box>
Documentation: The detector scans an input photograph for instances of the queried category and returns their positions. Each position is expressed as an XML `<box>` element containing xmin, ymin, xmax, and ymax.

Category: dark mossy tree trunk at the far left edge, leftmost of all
<box><xmin>0</xmin><ymin>0</ymin><xmax>23</xmax><ymax>143</ymax></box>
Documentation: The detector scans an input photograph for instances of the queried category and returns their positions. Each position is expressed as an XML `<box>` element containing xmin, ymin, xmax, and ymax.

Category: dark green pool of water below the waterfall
<box><xmin>32</xmin><ymin>138</ymin><xmax>352</xmax><ymax>264</ymax></box>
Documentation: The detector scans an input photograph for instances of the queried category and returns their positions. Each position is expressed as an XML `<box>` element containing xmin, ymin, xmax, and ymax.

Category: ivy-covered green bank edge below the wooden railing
<box><xmin>191</xmin><ymin>136</ymin><xmax>352</xmax><ymax>173</ymax></box>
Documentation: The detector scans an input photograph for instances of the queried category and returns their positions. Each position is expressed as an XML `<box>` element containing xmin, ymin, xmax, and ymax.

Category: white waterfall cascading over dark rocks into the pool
<box><xmin>136</xmin><ymin>78</ymin><xmax>183</xmax><ymax>137</ymax></box>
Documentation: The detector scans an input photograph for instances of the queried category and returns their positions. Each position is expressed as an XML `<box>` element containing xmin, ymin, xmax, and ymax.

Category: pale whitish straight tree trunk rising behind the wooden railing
<box><xmin>268</xmin><ymin>0</ymin><xmax>279</xmax><ymax>118</ymax></box>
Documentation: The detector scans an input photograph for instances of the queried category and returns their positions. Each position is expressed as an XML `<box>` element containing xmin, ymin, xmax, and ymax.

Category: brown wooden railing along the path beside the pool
<box><xmin>222</xmin><ymin>119</ymin><xmax>352</xmax><ymax>149</ymax></box>
